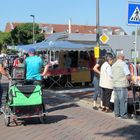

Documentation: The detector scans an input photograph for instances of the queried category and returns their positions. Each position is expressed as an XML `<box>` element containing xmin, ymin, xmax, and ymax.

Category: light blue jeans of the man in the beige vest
<box><xmin>114</xmin><ymin>87</ymin><xmax>128</xmax><ymax>117</ymax></box>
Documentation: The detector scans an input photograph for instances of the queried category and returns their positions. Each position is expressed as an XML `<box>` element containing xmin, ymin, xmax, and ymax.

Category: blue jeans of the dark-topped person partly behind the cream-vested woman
<box><xmin>93</xmin><ymin>76</ymin><xmax>102</xmax><ymax>101</ymax></box>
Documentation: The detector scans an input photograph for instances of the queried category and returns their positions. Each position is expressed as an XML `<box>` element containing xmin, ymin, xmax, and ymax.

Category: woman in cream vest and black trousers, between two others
<box><xmin>99</xmin><ymin>55</ymin><xmax>113</xmax><ymax>113</ymax></box>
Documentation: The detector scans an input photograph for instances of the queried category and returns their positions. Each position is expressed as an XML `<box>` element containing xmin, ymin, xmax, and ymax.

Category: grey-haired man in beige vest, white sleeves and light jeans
<box><xmin>112</xmin><ymin>54</ymin><xmax>131</xmax><ymax>119</ymax></box>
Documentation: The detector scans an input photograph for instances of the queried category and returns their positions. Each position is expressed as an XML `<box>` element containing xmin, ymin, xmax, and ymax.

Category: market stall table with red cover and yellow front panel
<box><xmin>44</xmin><ymin>68</ymin><xmax>91</xmax><ymax>88</ymax></box>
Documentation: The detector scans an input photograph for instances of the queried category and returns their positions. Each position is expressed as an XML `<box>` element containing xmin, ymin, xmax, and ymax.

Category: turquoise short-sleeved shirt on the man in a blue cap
<box><xmin>25</xmin><ymin>56</ymin><xmax>43</xmax><ymax>80</ymax></box>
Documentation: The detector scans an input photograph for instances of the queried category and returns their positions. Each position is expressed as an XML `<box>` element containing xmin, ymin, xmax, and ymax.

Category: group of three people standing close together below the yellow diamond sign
<box><xmin>93</xmin><ymin>53</ymin><xmax>131</xmax><ymax>119</ymax></box>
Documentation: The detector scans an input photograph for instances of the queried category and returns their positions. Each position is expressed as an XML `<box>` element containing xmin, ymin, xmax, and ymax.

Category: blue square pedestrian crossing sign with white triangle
<box><xmin>128</xmin><ymin>2</ymin><xmax>140</xmax><ymax>25</ymax></box>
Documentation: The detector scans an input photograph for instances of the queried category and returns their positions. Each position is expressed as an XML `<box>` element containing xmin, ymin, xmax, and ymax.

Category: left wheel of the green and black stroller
<box><xmin>4</xmin><ymin>105</ymin><xmax>11</xmax><ymax>126</ymax></box>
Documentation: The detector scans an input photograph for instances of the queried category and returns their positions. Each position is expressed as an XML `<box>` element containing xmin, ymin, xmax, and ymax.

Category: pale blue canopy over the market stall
<box><xmin>16</xmin><ymin>41</ymin><xmax>96</xmax><ymax>52</ymax></box>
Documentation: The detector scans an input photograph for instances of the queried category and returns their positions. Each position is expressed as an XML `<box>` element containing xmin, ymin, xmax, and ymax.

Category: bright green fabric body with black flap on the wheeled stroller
<box><xmin>8</xmin><ymin>85</ymin><xmax>42</xmax><ymax>106</ymax></box>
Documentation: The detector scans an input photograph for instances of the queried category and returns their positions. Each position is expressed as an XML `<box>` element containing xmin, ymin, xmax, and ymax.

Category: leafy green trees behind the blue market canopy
<box><xmin>0</xmin><ymin>23</ymin><xmax>45</xmax><ymax>52</ymax></box>
